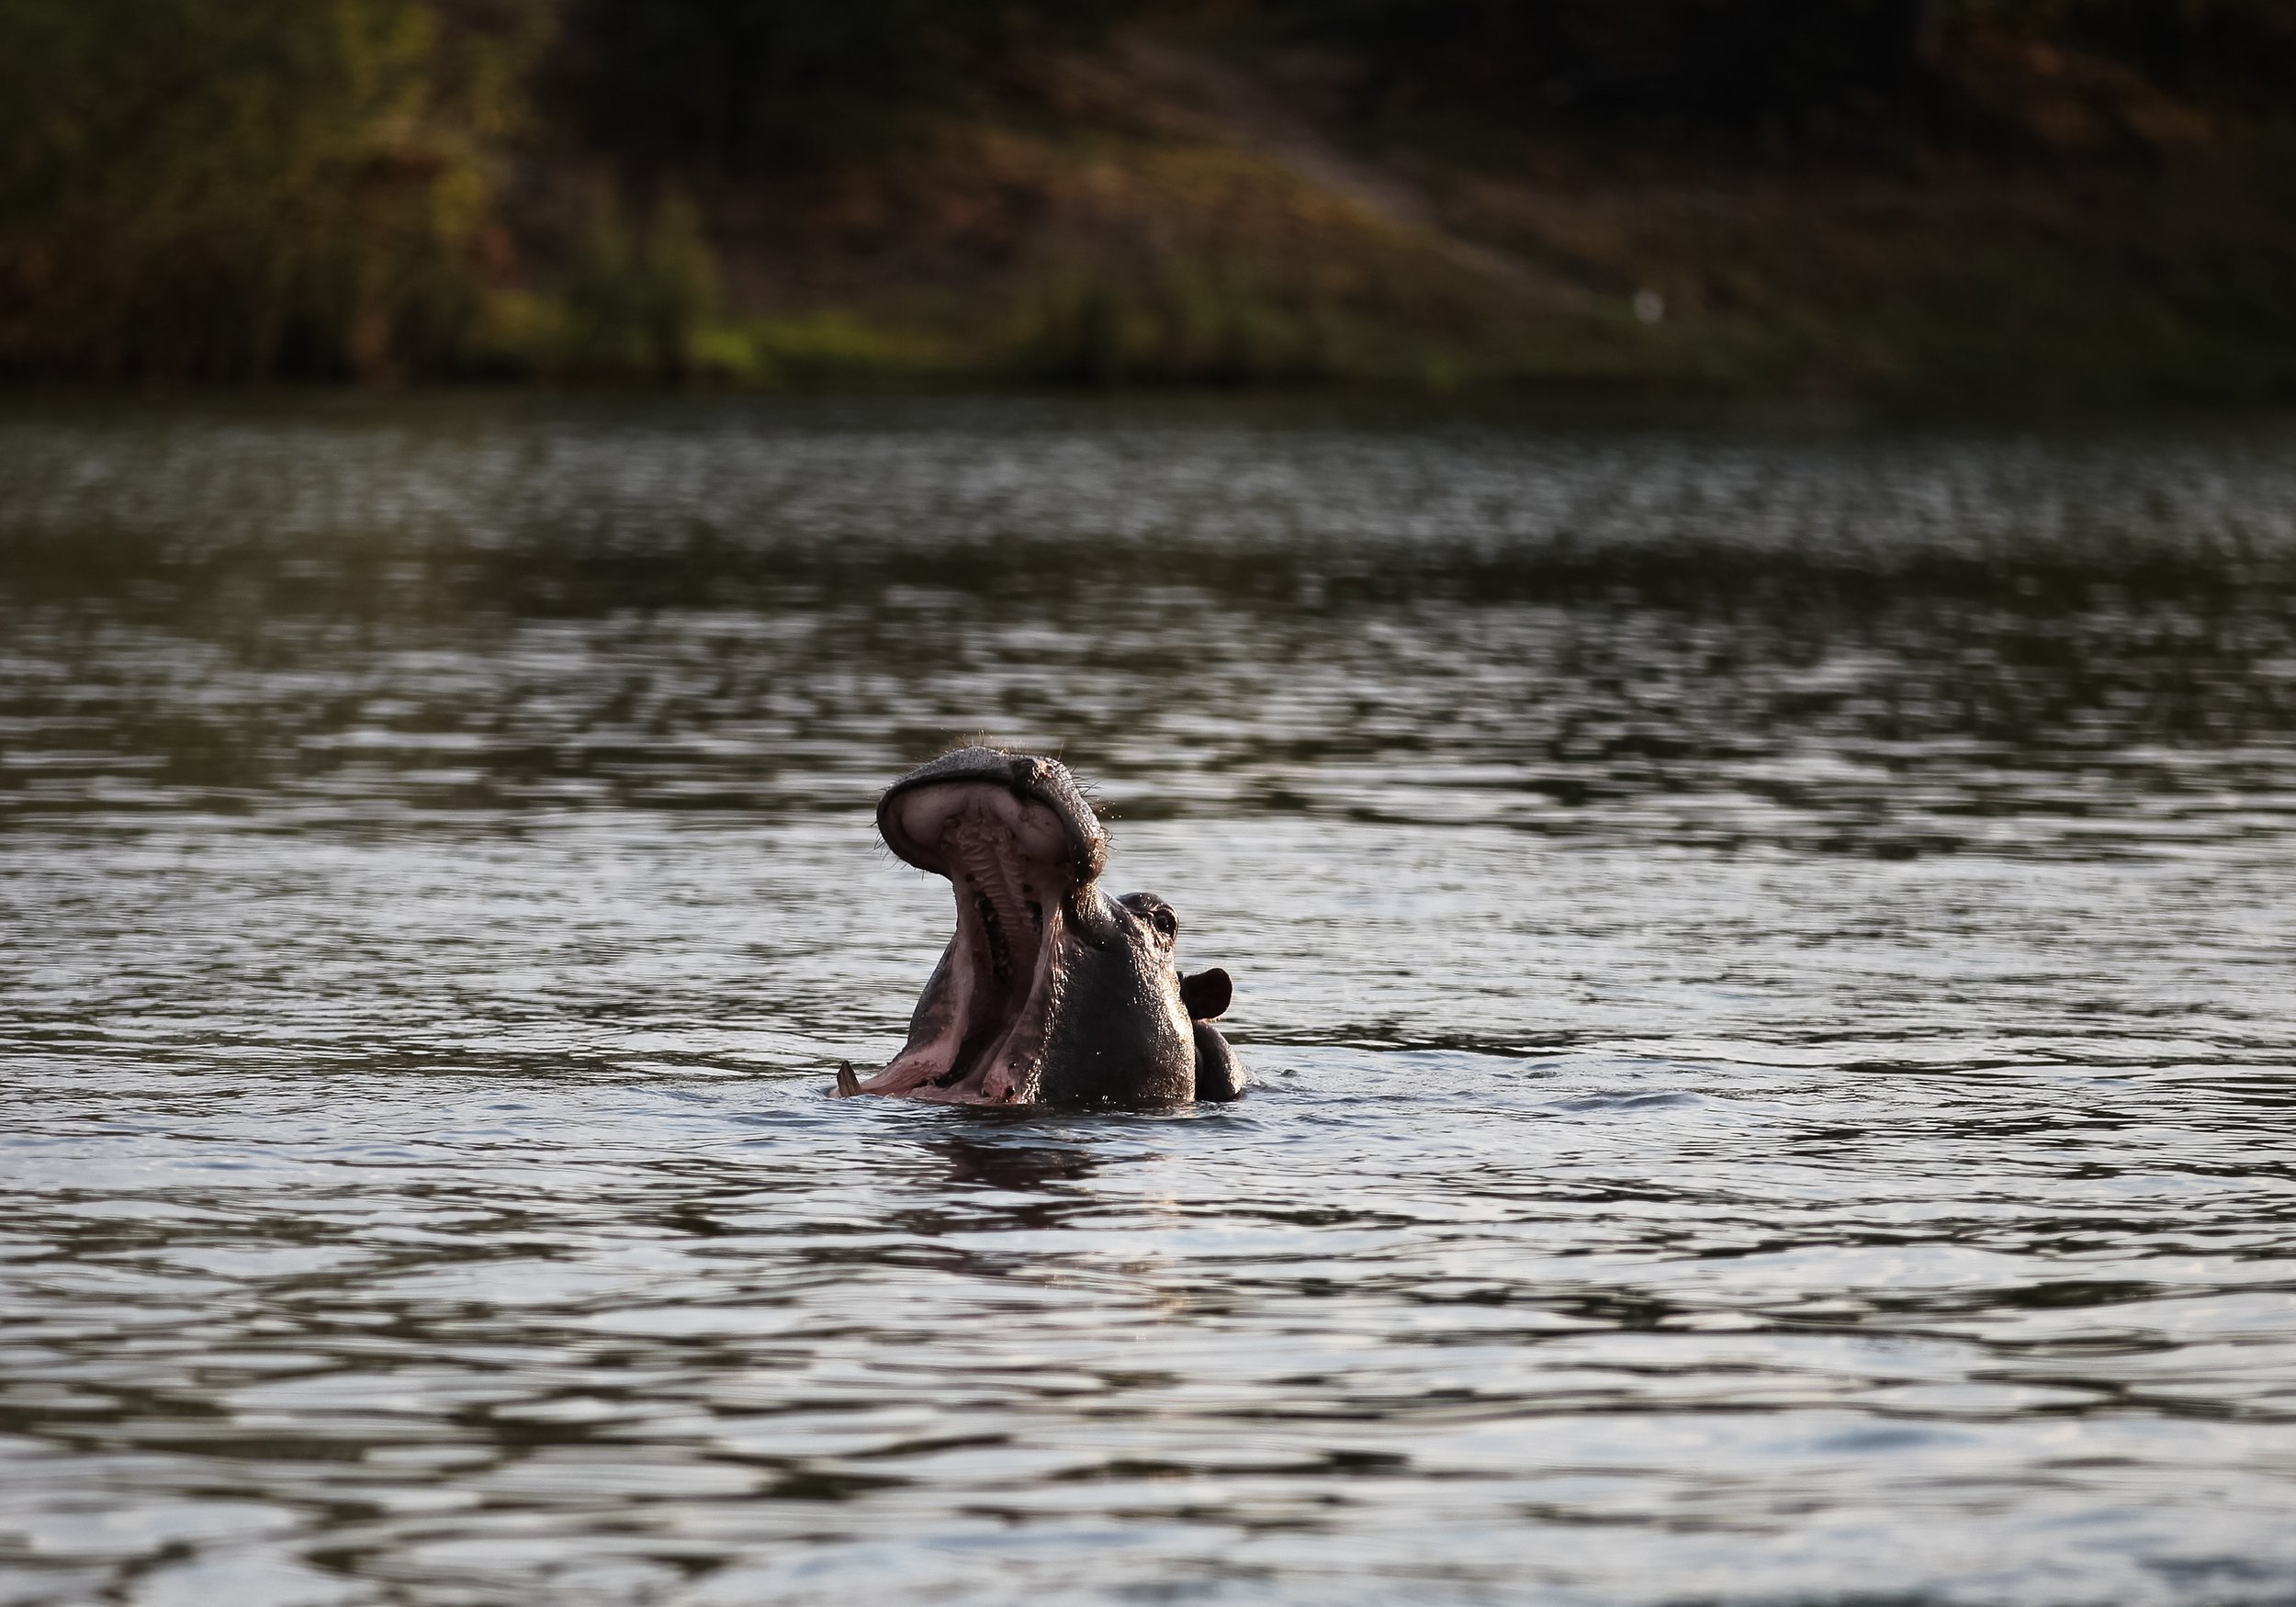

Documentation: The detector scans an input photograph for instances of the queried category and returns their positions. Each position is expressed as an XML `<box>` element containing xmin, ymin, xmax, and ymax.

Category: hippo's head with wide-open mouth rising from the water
<box><xmin>838</xmin><ymin>748</ymin><xmax>1244</xmax><ymax>1109</ymax></box>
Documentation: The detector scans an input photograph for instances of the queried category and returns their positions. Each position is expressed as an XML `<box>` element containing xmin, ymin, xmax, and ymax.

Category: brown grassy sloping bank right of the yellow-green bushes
<box><xmin>545</xmin><ymin>46</ymin><xmax>2296</xmax><ymax>404</ymax></box>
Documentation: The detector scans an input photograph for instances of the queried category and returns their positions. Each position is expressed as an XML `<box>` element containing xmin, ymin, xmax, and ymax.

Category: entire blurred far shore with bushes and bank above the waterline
<box><xmin>0</xmin><ymin>0</ymin><xmax>2296</xmax><ymax>399</ymax></box>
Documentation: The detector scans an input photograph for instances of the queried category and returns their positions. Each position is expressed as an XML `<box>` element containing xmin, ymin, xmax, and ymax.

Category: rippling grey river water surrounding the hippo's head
<box><xmin>0</xmin><ymin>402</ymin><xmax>2296</xmax><ymax>1607</ymax></box>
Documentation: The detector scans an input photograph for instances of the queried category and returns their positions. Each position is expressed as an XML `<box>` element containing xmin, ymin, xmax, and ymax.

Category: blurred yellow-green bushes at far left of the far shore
<box><xmin>0</xmin><ymin>0</ymin><xmax>546</xmax><ymax>379</ymax></box>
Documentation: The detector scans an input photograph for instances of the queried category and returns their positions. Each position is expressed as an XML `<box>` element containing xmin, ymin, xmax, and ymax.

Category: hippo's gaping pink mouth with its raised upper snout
<box><xmin>857</xmin><ymin>779</ymin><xmax>1079</xmax><ymax>1105</ymax></box>
